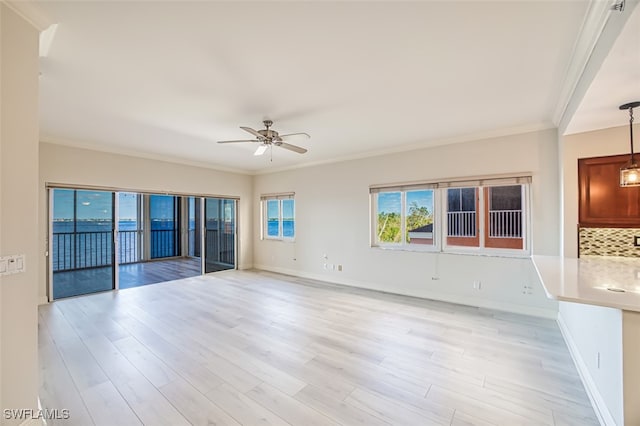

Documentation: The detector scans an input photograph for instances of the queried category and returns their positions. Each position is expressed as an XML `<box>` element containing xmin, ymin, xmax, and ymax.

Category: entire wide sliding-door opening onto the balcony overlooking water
<box><xmin>49</xmin><ymin>188</ymin><xmax>237</xmax><ymax>300</ymax></box>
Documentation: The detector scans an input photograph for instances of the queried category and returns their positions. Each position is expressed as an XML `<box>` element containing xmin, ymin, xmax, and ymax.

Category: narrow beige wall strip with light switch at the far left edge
<box><xmin>0</xmin><ymin>2</ymin><xmax>38</xmax><ymax>424</ymax></box>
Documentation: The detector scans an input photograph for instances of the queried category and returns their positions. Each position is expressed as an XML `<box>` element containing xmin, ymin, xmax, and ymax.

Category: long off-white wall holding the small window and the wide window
<box><xmin>254</xmin><ymin>129</ymin><xmax>560</xmax><ymax>318</ymax></box>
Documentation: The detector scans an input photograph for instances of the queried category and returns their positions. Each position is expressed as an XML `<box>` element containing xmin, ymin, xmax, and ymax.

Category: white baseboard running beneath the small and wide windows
<box><xmin>253</xmin><ymin>265</ymin><xmax>558</xmax><ymax>320</ymax></box>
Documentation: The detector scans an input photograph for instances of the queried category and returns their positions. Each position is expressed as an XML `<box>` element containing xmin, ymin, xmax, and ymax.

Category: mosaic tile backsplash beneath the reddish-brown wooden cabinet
<box><xmin>578</xmin><ymin>228</ymin><xmax>640</xmax><ymax>257</ymax></box>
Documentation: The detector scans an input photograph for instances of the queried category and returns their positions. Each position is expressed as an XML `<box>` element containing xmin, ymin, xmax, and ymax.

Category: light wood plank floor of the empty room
<box><xmin>39</xmin><ymin>271</ymin><xmax>598</xmax><ymax>426</ymax></box>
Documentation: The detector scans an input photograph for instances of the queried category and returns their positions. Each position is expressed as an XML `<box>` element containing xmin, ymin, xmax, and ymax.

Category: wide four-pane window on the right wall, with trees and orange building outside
<box><xmin>370</xmin><ymin>177</ymin><xmax>531</xmax><ymax>254</ymax></box>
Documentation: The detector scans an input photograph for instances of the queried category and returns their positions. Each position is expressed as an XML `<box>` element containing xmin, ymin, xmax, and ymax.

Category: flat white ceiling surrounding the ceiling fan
<box><xmin>37</xmin><ymin>1</ymin><xmax>640</xmax><ymax>173</ymax></box>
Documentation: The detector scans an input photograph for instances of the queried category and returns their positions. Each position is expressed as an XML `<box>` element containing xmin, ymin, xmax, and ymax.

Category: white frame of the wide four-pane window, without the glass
<box><xmin>369</xmin><ymin>174</ymin><xmax>532</xmax><ymax>257</ymax></box>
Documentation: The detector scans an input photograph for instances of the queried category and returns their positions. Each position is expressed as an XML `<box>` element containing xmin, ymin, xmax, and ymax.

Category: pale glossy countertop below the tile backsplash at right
<box><xmin>532</xmin><ymin>255</ymin><xmax>640</xmax><ymax>312</ymax></box>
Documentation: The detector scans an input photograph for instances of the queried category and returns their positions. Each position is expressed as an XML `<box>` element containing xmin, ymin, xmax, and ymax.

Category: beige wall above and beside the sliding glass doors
<box><xmin>39</xmin><ymin>143</ymin><xmax>253</xmax><ymax>301</ymax></box>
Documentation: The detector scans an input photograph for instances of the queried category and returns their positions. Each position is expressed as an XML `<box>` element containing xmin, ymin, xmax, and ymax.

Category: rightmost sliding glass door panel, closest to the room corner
<box><xmin>204</xmin><ymin>198</ymin><xmax>236</xmax><ymax>273</ymax></box>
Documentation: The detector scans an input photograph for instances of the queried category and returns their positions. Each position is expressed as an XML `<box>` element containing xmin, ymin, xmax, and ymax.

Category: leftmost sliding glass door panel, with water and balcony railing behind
<box><xmin>50</xmin><ymin>189</ymin><xmax>115</xmax><ymax>299</ymax></box>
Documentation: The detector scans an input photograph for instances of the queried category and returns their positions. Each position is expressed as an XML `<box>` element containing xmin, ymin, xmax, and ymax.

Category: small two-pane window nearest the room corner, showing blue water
<box><xmin>260</xmin><ymin>194</ymin><xmax>296</xmax><ymax>240</ymax></box>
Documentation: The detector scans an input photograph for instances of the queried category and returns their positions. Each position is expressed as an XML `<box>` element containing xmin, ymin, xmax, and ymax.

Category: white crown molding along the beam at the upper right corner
<box><xmin>553</xmin><ymin>0</ymin><xmax>639</xmax><ymax>133</ymax></box>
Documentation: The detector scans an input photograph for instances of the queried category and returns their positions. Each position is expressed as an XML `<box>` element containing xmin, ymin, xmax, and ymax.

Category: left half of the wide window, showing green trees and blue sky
<box><xmin>374</xmin><ymin>188</ymin><xmax>435</xmax><ymax>248</ymax></box>
